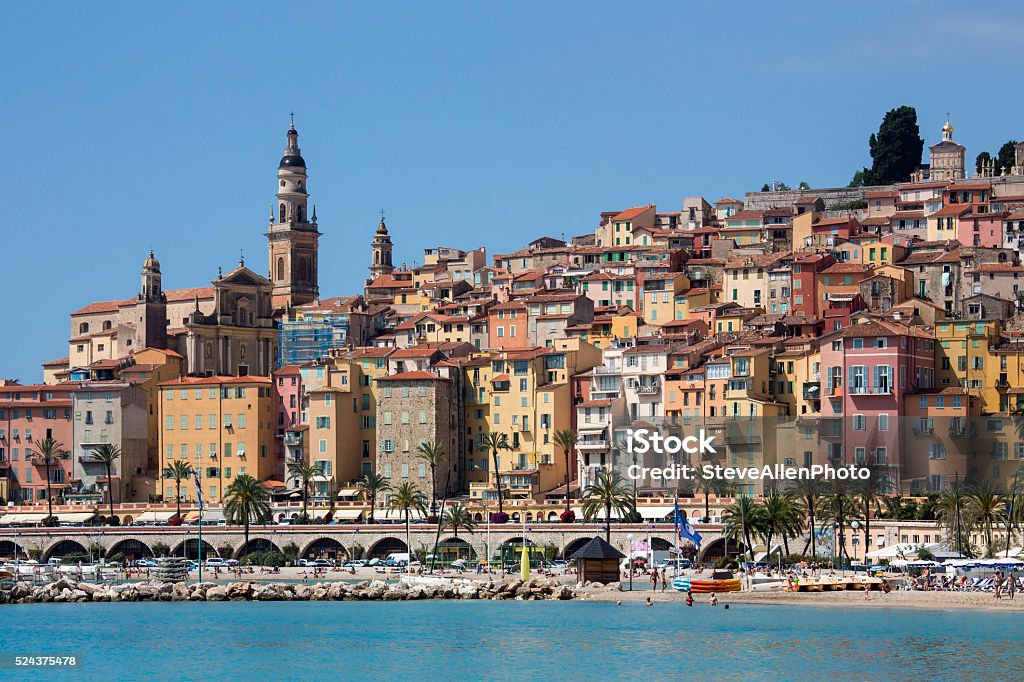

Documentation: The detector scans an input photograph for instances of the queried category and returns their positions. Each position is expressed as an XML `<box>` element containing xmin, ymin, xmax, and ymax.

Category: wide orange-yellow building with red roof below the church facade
<box><xmin>159</xmin><ymin>376</ymin><xmax>276</xmax><ymax>502</ymax></box>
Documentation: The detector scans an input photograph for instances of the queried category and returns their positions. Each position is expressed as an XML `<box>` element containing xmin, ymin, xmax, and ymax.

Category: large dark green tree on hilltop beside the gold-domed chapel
<box><xmin>851</xmin><ymin>106</ymin><xmax>925</xmax><ymax>185</ymax></box>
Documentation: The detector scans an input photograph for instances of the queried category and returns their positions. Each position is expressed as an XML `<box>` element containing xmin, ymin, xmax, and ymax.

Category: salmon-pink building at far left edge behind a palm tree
<box><xmin>0</xmin><ymin>385</ymin><xmax>74</xmax><ymax>504</ymax></box>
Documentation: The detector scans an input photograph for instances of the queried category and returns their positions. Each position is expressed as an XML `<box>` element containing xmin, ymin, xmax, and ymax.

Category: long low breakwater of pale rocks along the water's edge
<box><xmin>6</xmin><ymin>579</ymin><xmax>577</xmax><ymax>604</ymax></box>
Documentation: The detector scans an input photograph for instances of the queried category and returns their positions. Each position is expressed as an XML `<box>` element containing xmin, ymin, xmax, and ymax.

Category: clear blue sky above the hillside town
<box><xmin>0</xmin><ymin>2</ymin><xmax>1024</xmax><ymax>382</ymax></box>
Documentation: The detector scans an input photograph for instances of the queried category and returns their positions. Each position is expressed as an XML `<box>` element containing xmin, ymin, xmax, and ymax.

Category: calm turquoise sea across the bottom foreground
<box><xmin>0</xmin><ymin>601</ymin><xmax>1024</xmax><ymax>682</ymax></box>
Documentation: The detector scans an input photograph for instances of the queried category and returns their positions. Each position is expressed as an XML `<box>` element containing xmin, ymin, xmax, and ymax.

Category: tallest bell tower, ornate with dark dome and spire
<box><xmin>266</xmin><ymin>118</ymin><xmax>319</xmax><ymax>307</ymax></box>
